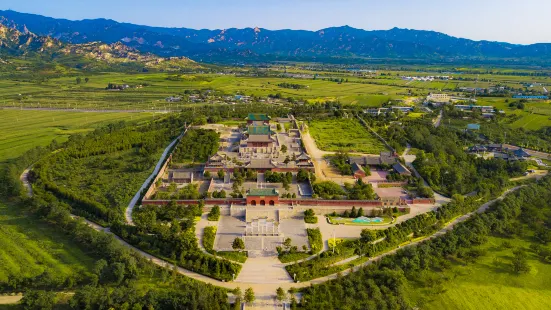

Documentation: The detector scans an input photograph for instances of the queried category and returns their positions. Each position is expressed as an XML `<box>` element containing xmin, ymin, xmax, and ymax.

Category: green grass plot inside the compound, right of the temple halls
<box><xmin>308</xmin><ymin>119</ymin><xmax>386</xmax><ymax>154</ymax></box>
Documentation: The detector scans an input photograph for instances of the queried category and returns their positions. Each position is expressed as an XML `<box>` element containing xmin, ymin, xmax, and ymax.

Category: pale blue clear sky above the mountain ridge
<box><xmin>0</xmin><ymin>0</ymin><xmax>551</xmax><ymax>44</ymax></box>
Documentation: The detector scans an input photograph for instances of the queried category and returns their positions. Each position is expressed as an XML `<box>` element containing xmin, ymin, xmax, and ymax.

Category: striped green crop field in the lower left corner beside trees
<box><xmin>0</xmin><ymin>203</ymin><xmax>95</xmax><ymax>283</ymax></box>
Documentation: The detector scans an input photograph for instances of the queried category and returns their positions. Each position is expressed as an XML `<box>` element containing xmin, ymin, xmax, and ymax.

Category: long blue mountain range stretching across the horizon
<box><xmin>0</xmin><ymin>10</ymin><xmax>551</xmax><ymax>62</ymax></box>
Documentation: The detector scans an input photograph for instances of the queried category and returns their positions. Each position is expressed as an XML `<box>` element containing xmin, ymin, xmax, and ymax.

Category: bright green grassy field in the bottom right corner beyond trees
<box><xmin>408</xmin><ymin>237</ymin><xmax>551</xmax><ymax>310</ymax></box>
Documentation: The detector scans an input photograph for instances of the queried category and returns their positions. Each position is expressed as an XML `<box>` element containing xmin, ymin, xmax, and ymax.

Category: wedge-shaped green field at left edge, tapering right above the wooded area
<box><xmin>0</xmin><ymin>110</ymin><xmax>152</xmax><ymax>163</ymax></box>
